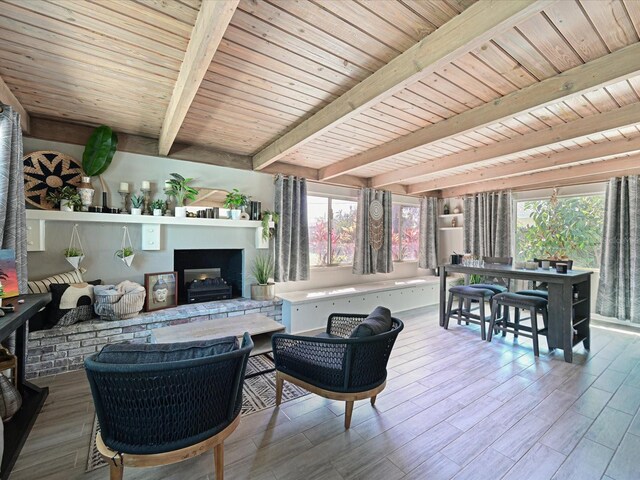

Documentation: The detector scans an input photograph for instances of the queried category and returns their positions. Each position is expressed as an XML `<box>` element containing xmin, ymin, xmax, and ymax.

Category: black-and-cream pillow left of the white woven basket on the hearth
<box><xmin>48</xmin><ymin>280</ymin><xmax>100</xmax><ymax>327</ymax></box>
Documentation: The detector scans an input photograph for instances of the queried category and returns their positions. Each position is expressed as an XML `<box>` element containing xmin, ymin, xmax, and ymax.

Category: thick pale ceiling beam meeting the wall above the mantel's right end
<box><xmin>253</xmin><ymin>0</ymin><xmax>553</xmax><ymax>172</ymax></box>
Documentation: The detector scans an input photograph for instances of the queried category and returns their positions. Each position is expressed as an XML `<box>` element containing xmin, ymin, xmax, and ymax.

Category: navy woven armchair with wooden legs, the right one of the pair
<box><xmin>272</xmin><ymin>310</ymin><xmax>404</xmax><ymax>428</ymax></box>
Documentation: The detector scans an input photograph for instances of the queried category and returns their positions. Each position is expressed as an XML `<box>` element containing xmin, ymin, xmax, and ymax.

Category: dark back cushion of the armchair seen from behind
<box><xmin>95</xmin><ymin>337</ymin><xmax>239</xmax><ymax>365</ymax></box>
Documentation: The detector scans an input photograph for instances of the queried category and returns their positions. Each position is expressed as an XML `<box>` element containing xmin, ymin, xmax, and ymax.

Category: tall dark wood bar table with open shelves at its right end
<box><xmin>440</xmin><ymin>264</ymin><xmax>593</xmax><ymax>363</ymax></box>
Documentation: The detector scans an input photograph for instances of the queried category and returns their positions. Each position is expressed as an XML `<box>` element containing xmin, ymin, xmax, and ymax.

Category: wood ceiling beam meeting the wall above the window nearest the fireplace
<box><xmin>320</xmin><ymin>43</ymin><xmax>640</xmax><ymax>180</ymax></box>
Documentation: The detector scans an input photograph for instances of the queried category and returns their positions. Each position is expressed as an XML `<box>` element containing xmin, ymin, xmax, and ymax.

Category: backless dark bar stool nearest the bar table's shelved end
<box><xmin>487</xmin><ymin>292</ymin><xmax>548</xmax><ymax>357</ymax></box>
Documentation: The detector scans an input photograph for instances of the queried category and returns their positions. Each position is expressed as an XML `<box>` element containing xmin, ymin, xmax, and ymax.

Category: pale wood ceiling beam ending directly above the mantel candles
<box><xmin>158</xmin><ymin>0</ymin><xmax>240</xmax><ymax>155</ymax></box>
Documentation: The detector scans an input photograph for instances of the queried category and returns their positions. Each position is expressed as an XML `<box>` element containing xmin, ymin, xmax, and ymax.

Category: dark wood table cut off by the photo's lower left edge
<box><xmin>0</xmin><ymin>294</ymin><xmax>49</xmax><ymax>480</ymax></box>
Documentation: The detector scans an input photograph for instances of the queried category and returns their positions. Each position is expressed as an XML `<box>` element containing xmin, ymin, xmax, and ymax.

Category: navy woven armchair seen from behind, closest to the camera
<box><xmin>85</xmin><ymin>333</ymin><xmax>253</xmax><ymax>480</ymax></box>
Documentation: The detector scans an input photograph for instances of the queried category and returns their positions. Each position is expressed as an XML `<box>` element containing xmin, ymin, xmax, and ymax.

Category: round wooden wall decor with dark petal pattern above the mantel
<box><xmin>22</xmin><ymin>150</ymin><xmax>84</xmax><ymax>210</ymax></box>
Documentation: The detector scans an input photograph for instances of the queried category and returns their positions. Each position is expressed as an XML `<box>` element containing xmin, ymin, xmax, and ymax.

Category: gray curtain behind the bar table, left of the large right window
<box><xmin>463</xmin><ymin>192</ymin><xmax>513</xmax><ymax>257</ymax></box>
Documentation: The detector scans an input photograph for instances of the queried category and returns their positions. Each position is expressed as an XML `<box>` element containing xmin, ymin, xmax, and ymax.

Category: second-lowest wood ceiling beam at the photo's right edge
<box><xmin>407</xmin><ymin>132</ymin><xmax>640</xmax><ymax>195</ymax></box>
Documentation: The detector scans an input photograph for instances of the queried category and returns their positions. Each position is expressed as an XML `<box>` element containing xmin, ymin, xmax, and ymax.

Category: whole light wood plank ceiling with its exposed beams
<box><xmin>0</xmin><ymin>0</ymin><xmax>640</xmax><ymax>195</ymax></box>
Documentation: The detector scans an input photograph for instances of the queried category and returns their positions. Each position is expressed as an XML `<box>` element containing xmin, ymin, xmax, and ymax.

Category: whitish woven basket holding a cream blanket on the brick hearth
<box><xmin>94</xmin><ymin>281</ymin><xmax>147</xmax><ymax>320</ymax></box>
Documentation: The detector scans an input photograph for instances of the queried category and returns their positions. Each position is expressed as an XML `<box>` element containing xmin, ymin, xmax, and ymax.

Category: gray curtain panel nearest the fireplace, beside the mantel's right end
<box><xmin>274</xmin><ymin>175</ymin><xmax>309</xmax><ymax>282</ymax></box>
